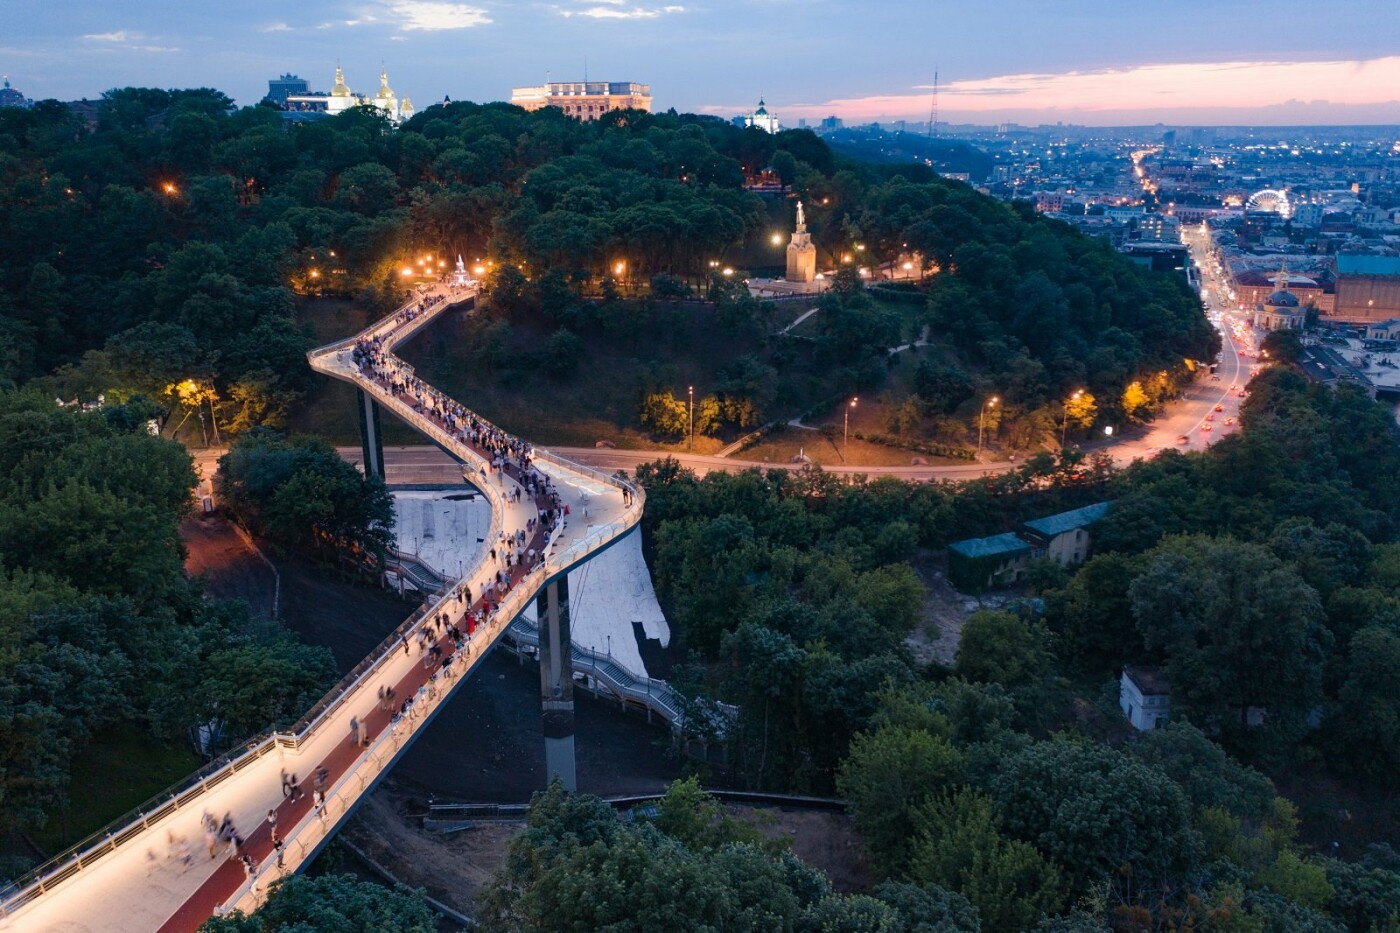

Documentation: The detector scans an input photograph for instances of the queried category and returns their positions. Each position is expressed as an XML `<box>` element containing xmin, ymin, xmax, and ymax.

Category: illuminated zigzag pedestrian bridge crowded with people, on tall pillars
<box><xmin>0</xmin><ymin>286</ymin><xmax>644</xmax><ymax>933</ymax></box>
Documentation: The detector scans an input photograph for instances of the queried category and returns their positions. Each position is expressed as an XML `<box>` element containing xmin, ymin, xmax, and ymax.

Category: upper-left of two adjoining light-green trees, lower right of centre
<box><xmin>836</xmin><ymin>727</ymin><xmax>962</xmax><ymax>881</ymax></box>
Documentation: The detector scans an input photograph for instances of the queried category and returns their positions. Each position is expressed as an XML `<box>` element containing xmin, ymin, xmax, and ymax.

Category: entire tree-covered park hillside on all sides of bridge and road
<box><xmin>0</xmin><ymin>88</ymin><xmax>1400</xmax><ymax>933</ymax></box>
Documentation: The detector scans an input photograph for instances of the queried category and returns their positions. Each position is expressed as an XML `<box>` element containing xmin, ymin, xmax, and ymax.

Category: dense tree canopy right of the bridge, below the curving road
<box><xmin>638</xmin><ymin>370</ymin><xmax>1400</xmax><ymax>932</ymax></box>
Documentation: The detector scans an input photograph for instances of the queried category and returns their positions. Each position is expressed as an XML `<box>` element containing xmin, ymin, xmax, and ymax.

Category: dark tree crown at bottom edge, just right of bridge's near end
<box><xmin>199</xmin><ymin>874</ymin><xmax>437</xmax><ymax>933</ymax></box>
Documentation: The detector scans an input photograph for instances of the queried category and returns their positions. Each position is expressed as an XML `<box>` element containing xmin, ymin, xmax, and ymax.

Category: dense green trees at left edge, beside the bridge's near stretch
<box><xmin>0</xmin><ymin>392</ymin><xmax>335</xmax><ymax>832</ymax></box>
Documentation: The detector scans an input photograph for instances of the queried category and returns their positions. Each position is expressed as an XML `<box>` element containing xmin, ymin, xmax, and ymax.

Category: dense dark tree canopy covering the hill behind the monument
<box><xmin>0</xmin><ymin>88</ymin><xmax>1215</xmax><ymax>445</ymax></box>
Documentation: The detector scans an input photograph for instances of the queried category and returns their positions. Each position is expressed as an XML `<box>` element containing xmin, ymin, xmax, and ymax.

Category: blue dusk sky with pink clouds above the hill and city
<box><xmin>8</xmin><ymin>0</ymin><xmax>1400</xmax><ymax>125</ymax></box>
